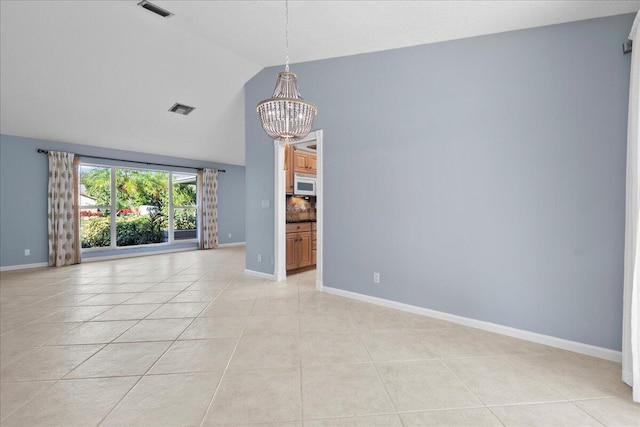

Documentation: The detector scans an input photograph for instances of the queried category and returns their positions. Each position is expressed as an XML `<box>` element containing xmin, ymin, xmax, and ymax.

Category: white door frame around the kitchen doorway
<box><xmin>273</xmin><ymin>130</ymin><xmax>324</xmax><ymax>291</ymax></box>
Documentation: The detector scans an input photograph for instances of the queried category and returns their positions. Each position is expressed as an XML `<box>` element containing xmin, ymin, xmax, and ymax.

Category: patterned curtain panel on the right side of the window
<box><xmin>198</xmin><ymin>169</ymin><xmax>218</xmax><ymax>249</ymax></box>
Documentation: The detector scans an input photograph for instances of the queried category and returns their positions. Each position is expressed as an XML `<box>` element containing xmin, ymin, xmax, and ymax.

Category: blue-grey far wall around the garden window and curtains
<box><xmin>0</xmin><ymin>135</ymin><xmax>245</xmax><ymax>267</ymax></box>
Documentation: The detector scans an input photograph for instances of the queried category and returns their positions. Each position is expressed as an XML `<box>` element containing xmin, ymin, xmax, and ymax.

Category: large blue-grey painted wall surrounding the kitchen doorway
<box><xmin>245</xmin><ymin>14</ymin><xmax>633</xmax><ymax>350</ymax></box>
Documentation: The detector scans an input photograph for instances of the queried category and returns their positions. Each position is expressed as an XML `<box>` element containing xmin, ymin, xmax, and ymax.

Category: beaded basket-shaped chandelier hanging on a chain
<box><xmin>257</xmin><ymin>1</ymin><xmax>318</xmax><ymax>145</ymax></box>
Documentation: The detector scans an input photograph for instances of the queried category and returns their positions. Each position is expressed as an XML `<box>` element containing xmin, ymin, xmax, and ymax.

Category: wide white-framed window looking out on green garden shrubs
<box><xmin>80</xmin><ymin>164</ymin><xmax>197</xmax><ymax>250</ymax></box>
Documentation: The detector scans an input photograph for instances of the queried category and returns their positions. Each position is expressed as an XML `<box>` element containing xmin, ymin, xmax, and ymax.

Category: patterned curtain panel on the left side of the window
<box><xmin>48</xmin><ymin>151</ymin><xmax>80</xmax><ymax>267</ymax></box>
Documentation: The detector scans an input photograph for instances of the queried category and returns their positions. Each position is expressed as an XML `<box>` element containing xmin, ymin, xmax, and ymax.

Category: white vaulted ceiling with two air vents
<box><xmin>0</xmin><ymin>0</ymin><xmax>640</xmax><ymax>164</ymax></box>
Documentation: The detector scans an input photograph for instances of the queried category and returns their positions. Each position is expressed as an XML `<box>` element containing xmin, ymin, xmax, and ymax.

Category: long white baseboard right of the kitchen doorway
<box><xmin>323</xmin><ymin>286</ymin><xmax>622</xmax><ymax>362</ymax></box>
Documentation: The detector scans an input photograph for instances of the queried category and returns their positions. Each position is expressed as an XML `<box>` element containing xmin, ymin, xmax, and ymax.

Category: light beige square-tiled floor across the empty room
<box><xmin>0</xmin><ymin>247</ymin><xmax>640</xmax><ymax>426</ymax></box>
